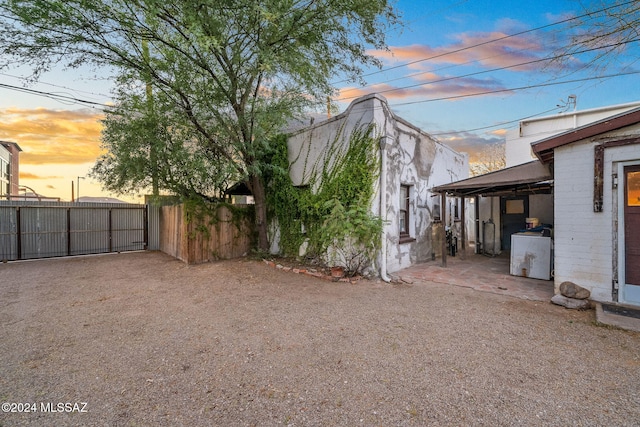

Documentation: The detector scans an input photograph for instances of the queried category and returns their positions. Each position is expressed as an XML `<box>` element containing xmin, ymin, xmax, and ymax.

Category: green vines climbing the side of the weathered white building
<box><xmin>267</xmin><ymin>126</ymin><xmax>382</xmax><ymax>274</ymax></box>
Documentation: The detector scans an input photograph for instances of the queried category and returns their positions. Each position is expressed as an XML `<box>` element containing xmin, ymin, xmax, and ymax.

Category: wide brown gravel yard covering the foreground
<box><xmin>0</xmin><ymin>253</ymin><xmax>640</xmax><ymax>426</ymax></box>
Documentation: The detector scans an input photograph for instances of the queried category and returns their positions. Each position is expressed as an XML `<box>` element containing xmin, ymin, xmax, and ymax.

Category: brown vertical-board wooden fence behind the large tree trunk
<box><xmin>160</xmin><ymin>205</ymin><xmax>254</xmax><ymax>264</ymax></box>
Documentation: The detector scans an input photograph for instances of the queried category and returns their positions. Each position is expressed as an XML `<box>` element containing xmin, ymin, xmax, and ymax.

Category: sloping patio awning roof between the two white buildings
<box><xmin>431</xmin><ymin>160</ymin><xmax>553</xmax><ymax>197</ymax></box>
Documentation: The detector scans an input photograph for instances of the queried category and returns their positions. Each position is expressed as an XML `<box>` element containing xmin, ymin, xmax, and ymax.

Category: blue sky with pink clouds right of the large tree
<box><xmin>336</xmin><ymin>0</ymin><xmax>640</xmax><ymax>157</ymax></box>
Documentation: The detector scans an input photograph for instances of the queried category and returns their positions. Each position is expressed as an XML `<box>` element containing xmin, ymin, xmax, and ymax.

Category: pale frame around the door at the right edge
<box><xmin>613</xmin><ymin>160</ymin><xmax>640</xmax><ymax>305</ymax></box>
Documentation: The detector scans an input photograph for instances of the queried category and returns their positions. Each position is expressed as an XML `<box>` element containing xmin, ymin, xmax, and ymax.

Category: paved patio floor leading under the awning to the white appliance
<box><xmin>394</xmin><ymin>253</ymin><xmax>553</xmax><ymax>302</ymax></box>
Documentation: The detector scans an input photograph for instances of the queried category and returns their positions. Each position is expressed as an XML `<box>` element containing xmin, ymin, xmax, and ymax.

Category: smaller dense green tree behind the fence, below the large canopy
<box><xmin>91</xmin><ymin>73</ymin><xmax>241</xmax><ymax>201</ymax></box>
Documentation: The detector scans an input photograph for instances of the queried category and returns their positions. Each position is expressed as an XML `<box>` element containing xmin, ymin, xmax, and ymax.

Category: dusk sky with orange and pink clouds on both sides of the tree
<box><xmin>0</xmin><ymin>0</ymin><xmax>640</xmax><ymax>201</ymax></box>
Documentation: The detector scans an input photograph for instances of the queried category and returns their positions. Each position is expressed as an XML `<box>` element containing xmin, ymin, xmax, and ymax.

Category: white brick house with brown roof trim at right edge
<box><xmin>532</xmin><ymin>108</ymin><xmax>640</xmax><ymax>306</ymax></box>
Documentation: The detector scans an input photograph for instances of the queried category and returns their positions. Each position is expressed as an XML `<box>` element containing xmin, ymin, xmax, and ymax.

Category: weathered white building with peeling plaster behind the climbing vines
<box><xmin>288</xmin><ymin>94</ymin><xmax>469</xmax><ymax>280</ymax></box>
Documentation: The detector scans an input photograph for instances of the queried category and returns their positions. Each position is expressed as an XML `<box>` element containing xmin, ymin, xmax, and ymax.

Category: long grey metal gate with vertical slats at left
<box><xmin>0</xmin><ymin>201</ymin><xmax>149</xmax><ymax>261</ymax></box>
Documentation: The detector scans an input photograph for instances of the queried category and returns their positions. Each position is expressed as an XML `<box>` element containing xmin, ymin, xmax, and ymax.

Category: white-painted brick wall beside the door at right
<box><xmin>554</xmin><ymin>126</ymin><xmax>640</xmax><ymax>301</ymax></box>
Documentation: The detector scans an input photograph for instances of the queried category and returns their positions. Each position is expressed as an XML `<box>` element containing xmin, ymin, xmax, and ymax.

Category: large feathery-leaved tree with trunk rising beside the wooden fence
<box><xmin>0</xmin><ymin>0</ymin><xmax>398</xmax><ymax>249</ymax></box>
